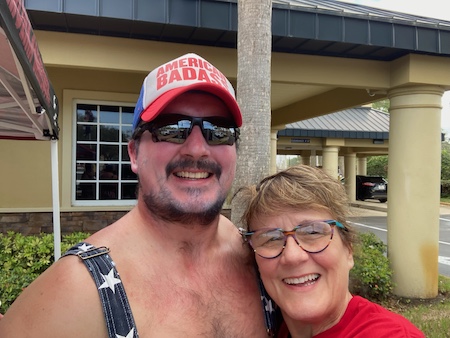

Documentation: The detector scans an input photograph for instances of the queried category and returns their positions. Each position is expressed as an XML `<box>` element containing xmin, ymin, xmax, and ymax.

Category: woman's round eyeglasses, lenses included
<box><xmin>239</xmin><ymin>220</ymin><xmax>345</xmax><ymax>258</ymax></box>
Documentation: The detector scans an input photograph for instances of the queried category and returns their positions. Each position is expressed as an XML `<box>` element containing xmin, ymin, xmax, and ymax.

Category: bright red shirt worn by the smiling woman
<box><xmin>277</xmin><ymin>296</ymin><xmax>425</xmax><ymax>338</ymax></box>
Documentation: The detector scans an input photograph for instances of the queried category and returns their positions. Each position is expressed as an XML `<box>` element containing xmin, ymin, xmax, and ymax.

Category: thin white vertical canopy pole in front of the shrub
<box><xmin>51</xmin><ymin>140</ymin><xmax>61</xmax><ymax>261</ymax></box>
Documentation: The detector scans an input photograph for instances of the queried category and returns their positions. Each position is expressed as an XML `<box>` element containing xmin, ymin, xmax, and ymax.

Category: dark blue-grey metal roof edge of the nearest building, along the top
<box><xmin>26</xmin><ymin>0</ymin><xmax>450</xmax><ymax>61</ymax></box>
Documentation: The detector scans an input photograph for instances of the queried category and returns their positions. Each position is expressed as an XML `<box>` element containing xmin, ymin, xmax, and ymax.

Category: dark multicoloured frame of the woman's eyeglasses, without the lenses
<box><xmin>239</xmin><ymin>219</ymin><xmax>347</xmax><ymax>259</ymax></box>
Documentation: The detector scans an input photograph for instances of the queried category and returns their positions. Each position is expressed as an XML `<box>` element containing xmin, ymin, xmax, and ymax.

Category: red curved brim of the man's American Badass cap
<box><xmin>141</xmin><ymin>83</ymin><xmax>242</xmax><ymax>127</ymax></box>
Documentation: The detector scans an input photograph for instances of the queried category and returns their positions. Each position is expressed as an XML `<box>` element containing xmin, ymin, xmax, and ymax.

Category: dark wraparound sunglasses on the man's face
<box><xmin>133</xmin><ymin>114</ymin><xmax>239</xmax><ymax>146</ymax></box>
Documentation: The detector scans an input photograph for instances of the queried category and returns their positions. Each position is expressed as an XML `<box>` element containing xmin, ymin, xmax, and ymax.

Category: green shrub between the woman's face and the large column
<box><xmin>350</xmin><ymin>233</ymin><xmax>394</xmax><ymax>301</ymax></box>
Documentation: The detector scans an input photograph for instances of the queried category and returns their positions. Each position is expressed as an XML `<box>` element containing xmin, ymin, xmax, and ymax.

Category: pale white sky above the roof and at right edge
<box><xmin>340</xmin><ymin>0</ymin><xmax>450</xmax><ymax>135</ymax></box>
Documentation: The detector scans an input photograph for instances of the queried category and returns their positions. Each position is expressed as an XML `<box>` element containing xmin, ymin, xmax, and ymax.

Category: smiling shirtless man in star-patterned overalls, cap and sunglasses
<box><xmin>0</xmin><ymin>54</ymin><xmax>267</xmax><ymax>338</ymax></box>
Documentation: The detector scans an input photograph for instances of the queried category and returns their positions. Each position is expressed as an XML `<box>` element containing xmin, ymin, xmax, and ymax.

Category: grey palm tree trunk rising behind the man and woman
<box><xmin>231</xmin><ymin>0</ymin><xmax>272</xmax><ymax>226</ymax></box>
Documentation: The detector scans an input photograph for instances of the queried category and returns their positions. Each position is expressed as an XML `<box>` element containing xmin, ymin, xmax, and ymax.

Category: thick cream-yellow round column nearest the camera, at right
<box><xmin>387</xmin><ymin>86</ymin><xmax>443</xmax><ymax>298</ymax></box>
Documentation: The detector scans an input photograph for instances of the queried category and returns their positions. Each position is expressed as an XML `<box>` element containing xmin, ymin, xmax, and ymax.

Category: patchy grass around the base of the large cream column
<box><xmin>381</xmin><ymin>276</ymin><xmax>450</xmax><ymax>338</ymax></box>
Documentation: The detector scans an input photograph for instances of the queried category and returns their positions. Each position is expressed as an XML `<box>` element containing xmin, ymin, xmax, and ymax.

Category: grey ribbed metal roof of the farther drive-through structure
<box><xmin>278</xmin><ymin>107</ymin><xmax>389</xmax><ymax>140</ymax></box>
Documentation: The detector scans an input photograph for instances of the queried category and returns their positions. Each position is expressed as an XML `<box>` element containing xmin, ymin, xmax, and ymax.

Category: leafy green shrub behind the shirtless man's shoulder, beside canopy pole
<box><xmin>0</xmin><ymin>232</ymin><xmax>89</xmax><ymax>313</ymax></box>
